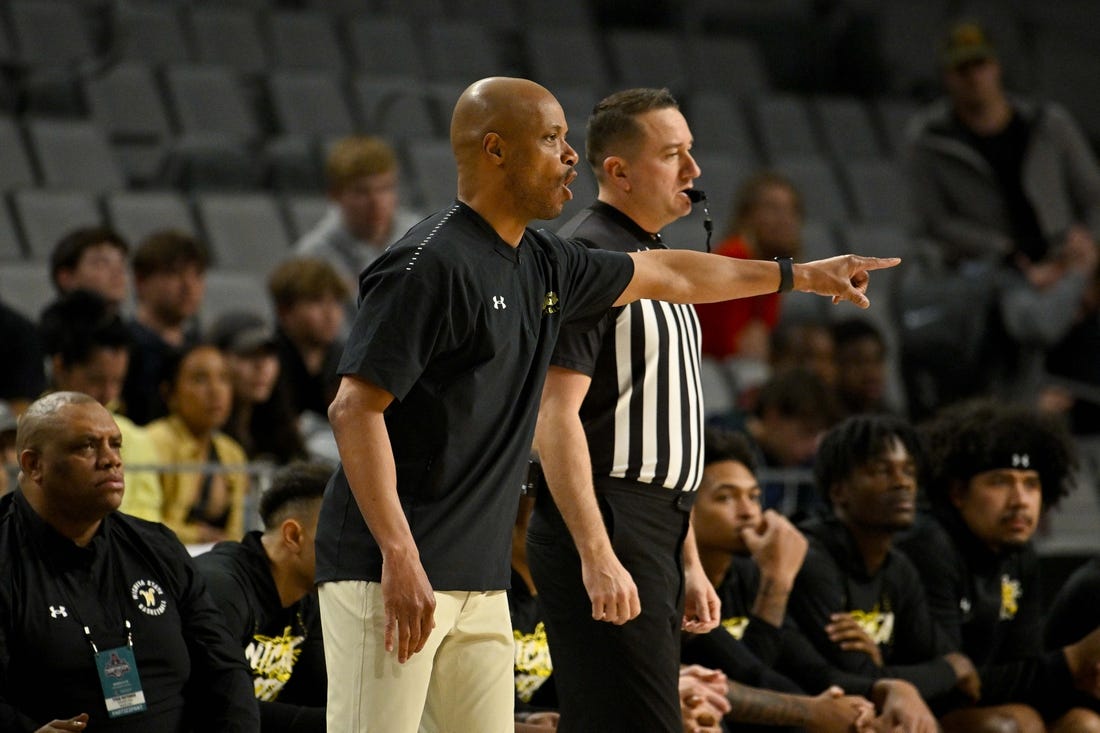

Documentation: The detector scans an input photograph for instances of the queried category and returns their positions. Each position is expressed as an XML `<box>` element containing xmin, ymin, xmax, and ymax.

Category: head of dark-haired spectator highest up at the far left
<box><xmin>50</xmin><ymin>227</ymin><xmax>130</xmax><ymax>311</ymax></box>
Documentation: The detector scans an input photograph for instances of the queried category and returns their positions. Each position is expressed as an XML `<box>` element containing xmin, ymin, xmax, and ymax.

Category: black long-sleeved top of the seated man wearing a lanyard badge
<box><xmin>0</xmin><ymin>491</ymin><xmax>260</xmax><ymax>733</ymax></box>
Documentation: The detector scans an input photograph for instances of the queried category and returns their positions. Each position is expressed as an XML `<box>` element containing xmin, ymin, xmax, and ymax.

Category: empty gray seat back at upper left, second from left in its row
<box><xmin>28</xmin><ymin>120</ymin><xmax>125</xmax><ymax>193</ymax></box>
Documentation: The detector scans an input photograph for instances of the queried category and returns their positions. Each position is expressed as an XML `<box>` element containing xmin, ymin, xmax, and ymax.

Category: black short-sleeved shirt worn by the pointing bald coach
<box><xmin>317</xmin><ymin>203</ymin><xmax>634</xmax><ymax>590</ymax></box>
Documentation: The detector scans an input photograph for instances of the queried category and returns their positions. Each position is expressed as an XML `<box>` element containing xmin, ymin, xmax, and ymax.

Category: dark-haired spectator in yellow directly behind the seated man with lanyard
<box><xmin>39</xmin><ymin>289</ymin><xmax>164</xmax><ymax>522</ymax></box>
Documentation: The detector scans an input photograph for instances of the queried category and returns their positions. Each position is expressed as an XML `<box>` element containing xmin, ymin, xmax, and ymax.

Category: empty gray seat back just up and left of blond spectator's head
<box><xmin>267</xmin><ymin>70</ymin><xmax>356</xmax><ymax>136</ymax></box>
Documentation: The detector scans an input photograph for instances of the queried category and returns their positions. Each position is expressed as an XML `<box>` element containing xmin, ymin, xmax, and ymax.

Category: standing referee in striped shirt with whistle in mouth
<box><xmin>528</xmin><ymin>89</ymin><xmax>721</xmax><ymax>732</ymax></box>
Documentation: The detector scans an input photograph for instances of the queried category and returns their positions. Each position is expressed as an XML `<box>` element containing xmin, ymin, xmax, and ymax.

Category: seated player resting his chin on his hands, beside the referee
<box><xmin>683</xmin><ymin>427</ymin><xmax>936</xmax><ymax>731</ymax></box>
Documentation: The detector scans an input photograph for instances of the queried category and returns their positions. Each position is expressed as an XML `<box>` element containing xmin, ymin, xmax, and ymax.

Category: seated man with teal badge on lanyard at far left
<box><xmin>0</xmin><ymin>392</ymin><xmax>260</xmax><ymax>733</ymax></box>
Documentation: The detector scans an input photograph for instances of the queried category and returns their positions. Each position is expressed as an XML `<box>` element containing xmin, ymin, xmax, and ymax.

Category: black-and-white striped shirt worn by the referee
<box><xmin>552</xmin><ymin>201</ymin><xmax>703</xmax><ymax>491</ymax></box>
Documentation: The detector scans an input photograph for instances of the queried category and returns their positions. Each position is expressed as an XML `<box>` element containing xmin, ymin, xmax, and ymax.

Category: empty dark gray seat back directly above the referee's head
<box><xmin>607</xmin><ymin>30</ymin><xmax>691</xmax><ymax>91</ymax></box>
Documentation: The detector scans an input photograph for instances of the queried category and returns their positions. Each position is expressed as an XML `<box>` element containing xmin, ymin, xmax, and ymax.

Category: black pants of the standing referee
<box><xmin>527</xmin><ymin>478</ymin><xmax>694</xmax><ymax>733</ymax></box>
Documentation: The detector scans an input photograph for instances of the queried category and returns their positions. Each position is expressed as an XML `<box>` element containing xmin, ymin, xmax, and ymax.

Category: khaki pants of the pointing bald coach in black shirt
<box><xmin>319</xmin><ymin>581</ymin><xmax>515</xmax><ymax>733</ymax></box>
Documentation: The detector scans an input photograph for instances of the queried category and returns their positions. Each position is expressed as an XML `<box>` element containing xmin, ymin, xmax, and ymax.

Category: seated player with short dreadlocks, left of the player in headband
<box><xmin>790</xmin><ymin>415</ymin><xmax>1035</xmax><ymax>732</ymax></box>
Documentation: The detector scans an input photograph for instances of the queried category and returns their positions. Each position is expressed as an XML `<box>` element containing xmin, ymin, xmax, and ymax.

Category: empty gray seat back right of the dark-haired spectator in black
<box><xmin>195</xmin><ymin>194</ymin><xmax>290</xmax><ymax>270</ymax></box>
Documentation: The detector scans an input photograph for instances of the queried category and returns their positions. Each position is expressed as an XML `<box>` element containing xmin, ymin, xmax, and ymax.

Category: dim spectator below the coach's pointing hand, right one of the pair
<box><xmin>833</xmin><ymin>317</ymin><xmax>893</xmax><ymax>416</ymax></box>
